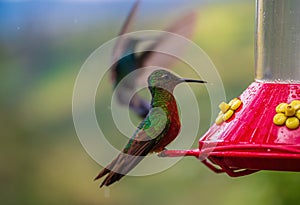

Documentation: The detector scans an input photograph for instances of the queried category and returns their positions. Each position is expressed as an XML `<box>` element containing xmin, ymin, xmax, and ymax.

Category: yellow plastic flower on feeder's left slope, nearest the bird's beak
<box><xmin>215</xmin><ymin>98</ymin><xmax>243</xmax><ymax>125</ymax></box>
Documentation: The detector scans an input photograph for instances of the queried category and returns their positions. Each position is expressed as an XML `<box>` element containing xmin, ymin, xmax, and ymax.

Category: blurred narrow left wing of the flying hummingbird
<box><xmin>112</xmin><ymin>0</ymin><xmax>140</xmax><ymax>66</ymax></box>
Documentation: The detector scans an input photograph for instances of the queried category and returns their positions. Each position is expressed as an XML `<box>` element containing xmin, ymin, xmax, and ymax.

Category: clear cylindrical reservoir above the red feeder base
<box><xmin>255</xmin><ymin>0</ymin><xmax>300</xmax><ymax>83</ymax></box>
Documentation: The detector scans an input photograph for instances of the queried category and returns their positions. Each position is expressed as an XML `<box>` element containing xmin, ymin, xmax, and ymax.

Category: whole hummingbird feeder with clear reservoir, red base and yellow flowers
<box><xmin>161</xmin><ymin>0</ymin><xmax>300</xmax><ymax>177</ymax></box>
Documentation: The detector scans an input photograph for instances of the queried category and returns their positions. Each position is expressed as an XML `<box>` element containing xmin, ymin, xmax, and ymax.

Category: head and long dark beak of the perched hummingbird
<box><xmin>148</xmin><ymin>69</ymin><xmax>206</xmax><ymax>92</ymax></box>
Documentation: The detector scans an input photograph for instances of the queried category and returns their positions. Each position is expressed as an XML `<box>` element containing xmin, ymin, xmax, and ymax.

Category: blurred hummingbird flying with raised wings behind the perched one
<box><xmin>111</xmin><ymin>0</ymin><xmax>196</xmax><ymax>118</ymax></box>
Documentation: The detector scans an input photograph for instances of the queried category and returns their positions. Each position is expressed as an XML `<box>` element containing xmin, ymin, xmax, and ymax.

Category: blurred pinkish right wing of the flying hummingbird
<box><xmin>138</xmin><ymin>11</ymin><xmax>197</xmax><ymax>85</ymax></box>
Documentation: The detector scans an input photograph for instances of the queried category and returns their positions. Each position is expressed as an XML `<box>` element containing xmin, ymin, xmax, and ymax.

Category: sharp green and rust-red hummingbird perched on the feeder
<box><xmin>95</xmin><ymin>69</ymin><xmax>206</xmax><ymax>187</ymax></box>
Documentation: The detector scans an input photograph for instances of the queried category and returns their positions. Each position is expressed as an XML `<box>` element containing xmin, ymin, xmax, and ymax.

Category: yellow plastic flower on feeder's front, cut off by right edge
<box><xmin>273</xmin><ymin>100</ymin><xmax>300</xmax><ymax>130</ymax></box>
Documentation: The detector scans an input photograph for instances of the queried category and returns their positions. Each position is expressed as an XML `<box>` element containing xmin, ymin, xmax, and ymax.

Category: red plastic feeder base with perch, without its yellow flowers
<box><xmin>161</xmin><ymin>82</ymin><xmax>300</xmax><ymax>177</ymax></box>
